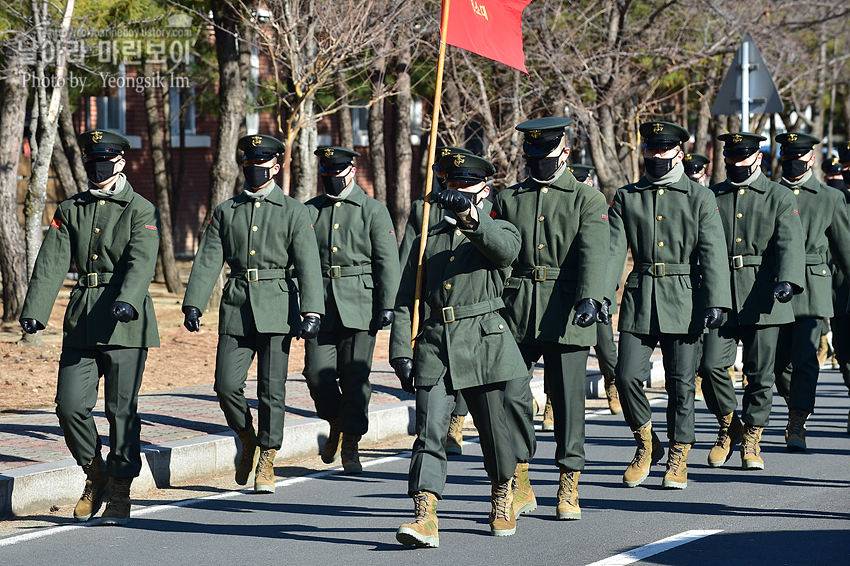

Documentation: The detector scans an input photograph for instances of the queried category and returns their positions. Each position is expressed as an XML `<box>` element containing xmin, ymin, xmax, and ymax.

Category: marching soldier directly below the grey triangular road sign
<box><xmin>702</xmin><ymin>132</ymin><xmax>805</xmax><ymax>470</ymax></box>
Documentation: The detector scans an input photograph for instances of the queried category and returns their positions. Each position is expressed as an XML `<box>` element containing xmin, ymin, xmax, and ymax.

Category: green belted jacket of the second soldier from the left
<box><xmin>183</xmin><ymin>185</ymin><xmax>325</xmax><ymax>336</ymax></box>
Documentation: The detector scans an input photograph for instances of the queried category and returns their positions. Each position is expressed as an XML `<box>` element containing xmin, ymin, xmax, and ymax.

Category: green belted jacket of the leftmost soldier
<box><xmin>21</xmin><ymin>181</ymin><xmax>160</xmax><ymax>348</ymax></box>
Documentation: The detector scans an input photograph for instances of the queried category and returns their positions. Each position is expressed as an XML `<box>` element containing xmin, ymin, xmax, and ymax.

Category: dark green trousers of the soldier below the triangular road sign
<box><xmin>702</xmin><ymin>325</ymin><xmax>780</xmax><ymax>427</ymax></box>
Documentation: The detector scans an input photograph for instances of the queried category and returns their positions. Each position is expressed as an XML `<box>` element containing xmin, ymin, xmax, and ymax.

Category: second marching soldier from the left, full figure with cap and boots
<box><xmin>183</xmin><ymin>135</ymin><xmax>324</xmax><ymax>493</ymax></box>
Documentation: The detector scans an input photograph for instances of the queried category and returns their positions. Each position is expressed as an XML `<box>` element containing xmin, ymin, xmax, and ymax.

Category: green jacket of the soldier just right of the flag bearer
<box><xmin>493</xmin><ymin>171</ymin><xmax>608</xmax><ymax>346</ymax></box>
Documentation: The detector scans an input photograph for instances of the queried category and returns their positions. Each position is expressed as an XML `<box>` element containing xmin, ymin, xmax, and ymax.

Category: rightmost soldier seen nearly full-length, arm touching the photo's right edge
<box><xmin>774</xmin><ymin>132</ymin><xmax>850</xmax><ymax>452</ymax></box>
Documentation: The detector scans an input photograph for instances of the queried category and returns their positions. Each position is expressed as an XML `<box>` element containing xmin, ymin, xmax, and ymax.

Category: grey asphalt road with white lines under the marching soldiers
<box><xmin>0</xmin><ymin>371</ymin><xmax>850</xmax><ymax>566</ymax></box>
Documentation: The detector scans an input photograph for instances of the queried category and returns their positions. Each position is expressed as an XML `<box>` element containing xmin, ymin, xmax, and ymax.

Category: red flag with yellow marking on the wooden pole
<box><xmin>443</xmin><ymin>0</ymin><xmax>531</xmax><ymax>75</ymax></box>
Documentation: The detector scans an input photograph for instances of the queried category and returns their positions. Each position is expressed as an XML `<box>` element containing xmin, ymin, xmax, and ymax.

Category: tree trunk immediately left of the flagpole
<box><xmin>390</xmin><ymin>45</ymin><xmax>413</xmax><ymax>243</ymax></box>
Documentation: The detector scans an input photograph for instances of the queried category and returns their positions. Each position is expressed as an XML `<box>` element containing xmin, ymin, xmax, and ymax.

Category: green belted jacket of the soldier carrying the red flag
<box><xmin>390</xmin><ymin>201</ymin><xmax>528</xmax><ymax>390</ymax></box>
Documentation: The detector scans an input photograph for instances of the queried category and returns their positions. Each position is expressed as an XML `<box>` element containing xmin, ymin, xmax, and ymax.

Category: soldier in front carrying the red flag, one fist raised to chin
<box><xmin>390</xmin><ymin>153</ymin><xmax>526</xmax><ymax>547</ymax></box>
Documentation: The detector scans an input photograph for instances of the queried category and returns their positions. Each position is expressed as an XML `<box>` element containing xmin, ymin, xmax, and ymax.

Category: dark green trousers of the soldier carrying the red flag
<box><xmin>408</xmin><ymin>375</ymin><xmax>519</xmax><ymax>499</ymax></box>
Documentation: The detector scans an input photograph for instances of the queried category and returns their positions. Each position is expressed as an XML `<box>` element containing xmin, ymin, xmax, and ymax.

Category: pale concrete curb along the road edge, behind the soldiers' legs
<box><xmin>0</xmin><ymin>359</ymin><xmax>664</xmax><ymax>519</ymax></box>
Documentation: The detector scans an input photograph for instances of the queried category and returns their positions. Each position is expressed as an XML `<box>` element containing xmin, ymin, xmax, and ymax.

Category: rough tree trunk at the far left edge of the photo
<box><xmin>0</xmin><ymin>43</ymin><xmax>28</xmax><ymax>322</ymax></box>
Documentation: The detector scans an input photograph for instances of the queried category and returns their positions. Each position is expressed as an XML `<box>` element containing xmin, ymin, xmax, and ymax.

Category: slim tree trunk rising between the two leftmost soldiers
<box><xmin>144</xmin><ymin>61</ymin><xmax>183</xmax><ymax>293</ymax></box>
